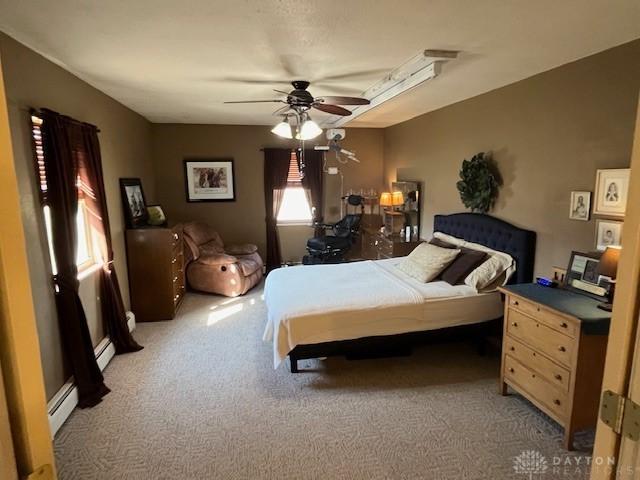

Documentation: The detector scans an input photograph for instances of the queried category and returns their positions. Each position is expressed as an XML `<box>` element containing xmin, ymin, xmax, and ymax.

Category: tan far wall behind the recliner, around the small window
<box><xmin>153</xmin><ymin>124</ymin><xmax>383</xmax><ymax>260</ymax></box>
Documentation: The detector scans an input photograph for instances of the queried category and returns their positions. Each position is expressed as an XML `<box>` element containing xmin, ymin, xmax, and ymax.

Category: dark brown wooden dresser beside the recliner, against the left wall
<box><xmin>126</xmin><ymin>224</ymin><xmax>185</xmax><ymax>322</ymax></box>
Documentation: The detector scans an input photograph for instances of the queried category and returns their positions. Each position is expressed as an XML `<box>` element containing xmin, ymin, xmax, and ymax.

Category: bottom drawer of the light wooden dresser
<box><xmin>504</xmin><ymin>355</ymin><xmax>568</xmax><ymax>419</ymax></box>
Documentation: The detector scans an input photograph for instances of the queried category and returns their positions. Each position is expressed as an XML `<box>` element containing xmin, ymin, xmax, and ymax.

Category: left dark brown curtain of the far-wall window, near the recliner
<box><xmin>264</xmin><ymin>148</ymin><xmax>291</xmax><ymax>271</ymax></box>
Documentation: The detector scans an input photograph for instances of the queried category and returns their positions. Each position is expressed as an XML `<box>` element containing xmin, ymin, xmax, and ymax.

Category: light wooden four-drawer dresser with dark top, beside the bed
<box><xmin>499</xmin><ymin>284</ymin><xmax>611</xmax><ymax>450</ymax></box>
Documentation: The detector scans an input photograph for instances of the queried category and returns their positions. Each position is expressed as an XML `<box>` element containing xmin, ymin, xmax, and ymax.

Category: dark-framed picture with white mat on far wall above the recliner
<box><xmin>184</xmin><ymin>159</ymin><xmax>236</xmax><ymax>202</ymax></box>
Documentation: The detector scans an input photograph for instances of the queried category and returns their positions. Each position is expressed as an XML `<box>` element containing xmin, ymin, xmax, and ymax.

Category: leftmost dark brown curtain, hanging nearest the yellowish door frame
<box><xmin>41</xmin><ymin>110</ymin><xmax>109</xmax><ymax>408</ymax></box>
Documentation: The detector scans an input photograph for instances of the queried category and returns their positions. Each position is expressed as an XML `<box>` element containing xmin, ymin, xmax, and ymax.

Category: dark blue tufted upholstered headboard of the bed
<box><xmin>433</xmin><ymin>213</ymin><xmax>536</xmax><ymax>283</ymax></box>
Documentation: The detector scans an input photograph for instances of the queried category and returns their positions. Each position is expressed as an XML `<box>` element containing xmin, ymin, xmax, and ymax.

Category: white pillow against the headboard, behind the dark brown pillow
<box><xmin>433</xmin><ymin>232</ymin><xmax>516</xmax><ymax>291</ymax></box>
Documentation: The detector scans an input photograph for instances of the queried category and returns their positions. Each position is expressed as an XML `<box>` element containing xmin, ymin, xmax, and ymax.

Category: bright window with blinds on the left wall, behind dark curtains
<box><xmin>31</xmin><ymin>116</ymin><xmax>99</xmax><ymax>275</ymax></box>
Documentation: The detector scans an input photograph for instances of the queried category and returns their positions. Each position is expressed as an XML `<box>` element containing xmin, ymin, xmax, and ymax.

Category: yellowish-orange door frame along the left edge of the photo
<box><xmin>0</xmin><ymin>46</ymin><xmax>56</xmax><ymax>480</ymax></box>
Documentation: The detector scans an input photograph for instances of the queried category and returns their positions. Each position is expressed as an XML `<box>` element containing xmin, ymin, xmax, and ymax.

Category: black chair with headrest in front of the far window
<box><xmin>302</xmin><ymin>195</ymin><xmax>364</xmax><ymax>265</ymax></box>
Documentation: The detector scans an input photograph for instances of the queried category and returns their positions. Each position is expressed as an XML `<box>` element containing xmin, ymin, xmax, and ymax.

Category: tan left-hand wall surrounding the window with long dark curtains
<box><xmin>0</xmin><ymin>33</ymin><xmax>155</xmax><ymax>398</ymax></box>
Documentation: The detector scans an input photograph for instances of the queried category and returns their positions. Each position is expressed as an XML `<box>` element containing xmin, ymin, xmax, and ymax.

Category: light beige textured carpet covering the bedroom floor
<box><xmin>55</xmin><ymin>288</ymin><xmax>592</xmax><ymax>480</ymax></box>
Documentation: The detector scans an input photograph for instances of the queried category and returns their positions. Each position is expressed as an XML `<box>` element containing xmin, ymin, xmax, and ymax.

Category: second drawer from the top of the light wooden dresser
<box><xmin>507</xmin><ymin>309</ymin><xmax>575</xmax><ymax>367</ymax></box>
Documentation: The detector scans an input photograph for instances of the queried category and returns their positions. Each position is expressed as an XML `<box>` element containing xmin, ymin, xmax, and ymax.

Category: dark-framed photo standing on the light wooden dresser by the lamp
<box><xmin>564</xmin><ymin>252</ymin><xmax>611</xmax><ymax>300</ymax></box>
